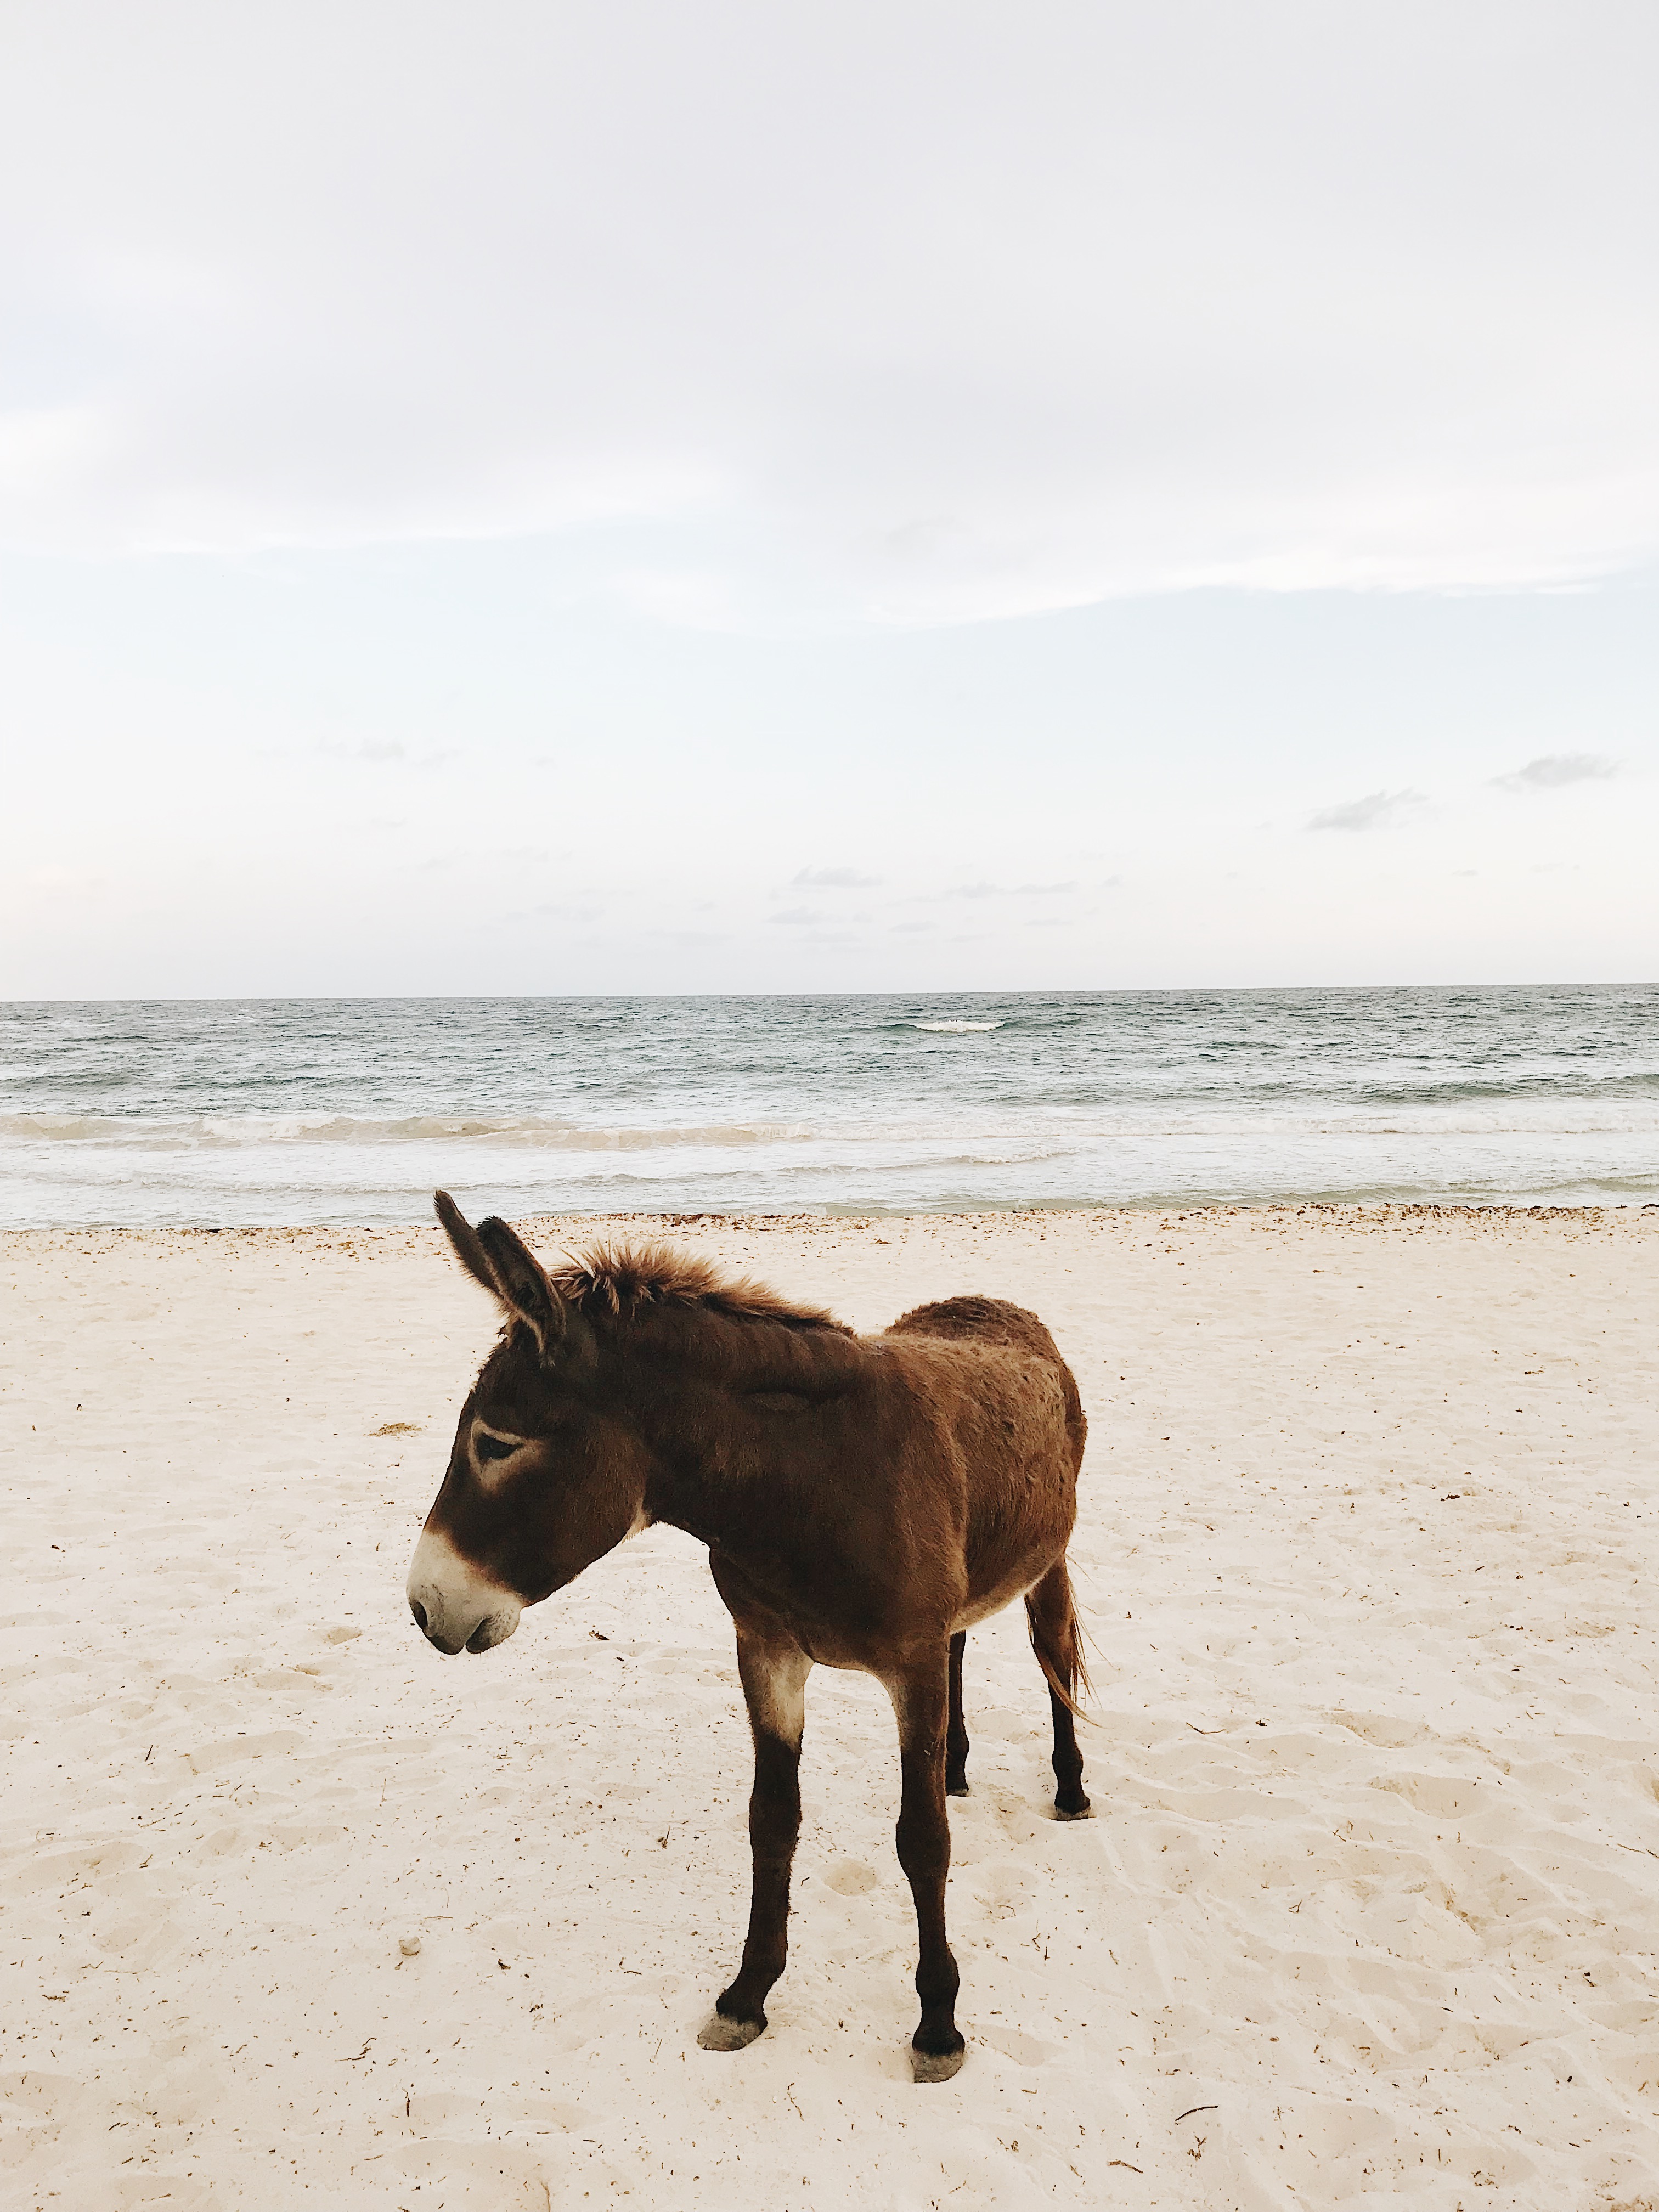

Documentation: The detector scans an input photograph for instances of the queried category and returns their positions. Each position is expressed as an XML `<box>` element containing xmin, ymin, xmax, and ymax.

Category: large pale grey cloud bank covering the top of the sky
<box><xmin>0</xmin><ymin>13</ymin><xmax>1659</xmax><ymax>628</ymax></box>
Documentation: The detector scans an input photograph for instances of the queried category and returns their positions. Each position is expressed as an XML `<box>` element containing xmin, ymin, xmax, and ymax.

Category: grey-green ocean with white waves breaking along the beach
<box><xmin>0</xmin><ymin>986</ymin><xmax>1659</xmax><ymax>1228</ymax></box>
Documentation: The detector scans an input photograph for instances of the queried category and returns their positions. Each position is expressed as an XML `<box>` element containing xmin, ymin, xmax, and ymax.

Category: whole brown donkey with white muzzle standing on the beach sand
<box><xmin>409</xmin><ymin>1190</ymin><xmax>1088</xmax><ymax>2081</ymax></box>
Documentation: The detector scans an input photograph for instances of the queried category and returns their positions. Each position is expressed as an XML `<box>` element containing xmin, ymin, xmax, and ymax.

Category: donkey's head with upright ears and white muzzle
<box><xmin>409</xmin><ymin>1190</ymin><xmax>648</xmax><ymax>1652</ymax></box>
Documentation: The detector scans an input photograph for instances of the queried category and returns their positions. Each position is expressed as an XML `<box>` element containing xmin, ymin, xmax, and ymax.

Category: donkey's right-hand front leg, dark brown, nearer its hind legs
<box><xmin>887</xmin><ymin>1644</ymin><xmax>962</xmax><ymax>2081</ymax></box>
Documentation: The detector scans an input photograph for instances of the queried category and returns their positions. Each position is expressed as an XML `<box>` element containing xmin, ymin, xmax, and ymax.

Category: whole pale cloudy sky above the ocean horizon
<box><xmin>0</xmin><ymin>0</ymin><xmax>1659</xmax><ymax>997</ymax></box>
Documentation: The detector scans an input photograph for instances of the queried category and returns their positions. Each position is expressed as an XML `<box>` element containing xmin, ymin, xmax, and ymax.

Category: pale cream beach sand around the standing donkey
<box><xmin>0</xmin><ymin>1207</ymin><xmax>1659</xmax><ymax>2212</ymax></box>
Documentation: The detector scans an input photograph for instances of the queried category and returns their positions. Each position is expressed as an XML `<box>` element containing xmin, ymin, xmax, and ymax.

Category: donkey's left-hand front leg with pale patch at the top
<box><xmin>697</xmin><ymin>1621</ymin><xmax>812</xmax><ymax>2051</ymax></box>
